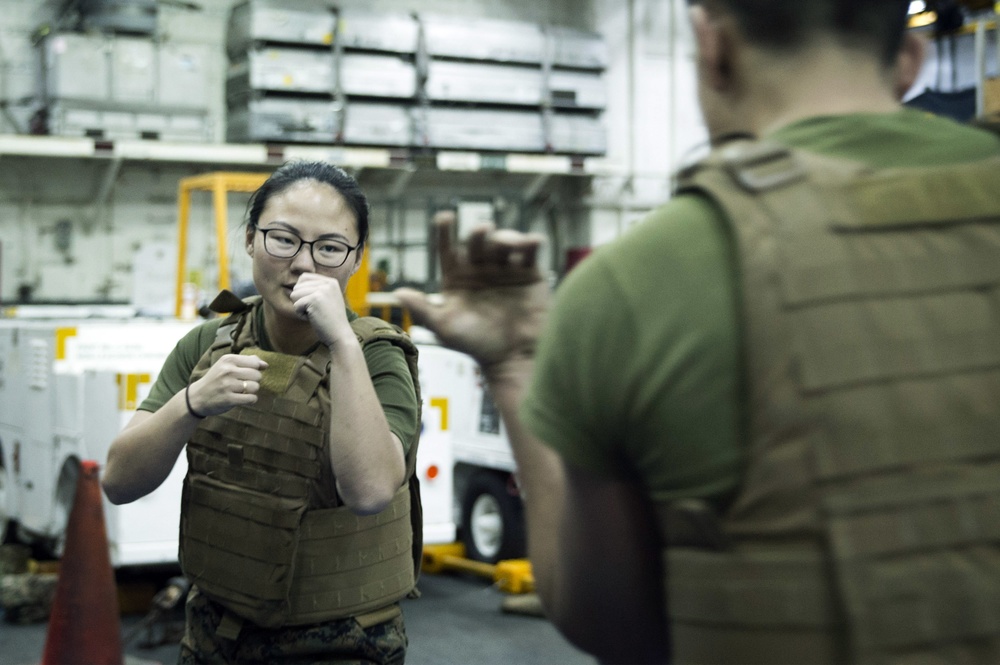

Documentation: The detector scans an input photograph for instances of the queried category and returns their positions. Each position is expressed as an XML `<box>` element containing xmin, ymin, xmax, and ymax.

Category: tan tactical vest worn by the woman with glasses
<box><xmin>180</xmin><ymin>298</ymin><xmax>423</xmax><ymax>637</ymax></box>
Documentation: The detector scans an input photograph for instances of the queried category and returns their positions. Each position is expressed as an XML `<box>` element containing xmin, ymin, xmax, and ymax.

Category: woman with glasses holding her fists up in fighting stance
<box><xmin>103</xmin><ymin>162</ymin><xmax>420</xmax><ymax>663</ymax></box>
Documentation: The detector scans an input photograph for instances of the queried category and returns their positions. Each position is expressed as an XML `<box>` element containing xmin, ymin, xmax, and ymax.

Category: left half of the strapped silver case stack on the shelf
<box><xmin>226</xmin><ymin>0</ymin><xmax>428</xmax><ymax>147</ymax></box>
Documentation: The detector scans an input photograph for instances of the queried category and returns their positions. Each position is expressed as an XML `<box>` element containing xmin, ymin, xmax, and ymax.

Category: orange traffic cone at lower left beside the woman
<box><xmin>42</xmin><ymin>461</ymin><xmax>124</xmax><ymax>665</ymax></box>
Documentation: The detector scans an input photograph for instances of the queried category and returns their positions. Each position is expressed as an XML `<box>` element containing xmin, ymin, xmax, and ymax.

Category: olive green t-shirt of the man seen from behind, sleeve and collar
<box><xmin>520</xmin><ymin>109</ymin><xmax>1000</xmax><ymax>501</ymax></box>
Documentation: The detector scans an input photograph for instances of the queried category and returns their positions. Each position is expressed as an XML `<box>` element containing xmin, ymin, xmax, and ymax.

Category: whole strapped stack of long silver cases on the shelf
<box><xmin>226</xmin><ymin>0</ymin><xmax>607</xmax><ymax>154</ymax></box>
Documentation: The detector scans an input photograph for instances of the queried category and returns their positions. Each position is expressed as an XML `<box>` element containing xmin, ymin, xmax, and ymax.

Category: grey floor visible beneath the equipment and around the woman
<box><xmin>0</xmin><ymin>574</ymin><xmax>595</xmax><ymax>665</ymax></box>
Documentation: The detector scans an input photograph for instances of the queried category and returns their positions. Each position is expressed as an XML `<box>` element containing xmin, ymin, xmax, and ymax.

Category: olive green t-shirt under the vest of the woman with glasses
<box><xmin>139</xmin><ymin>308</ymin><xmax>420</xmax><ymax>452</ymax></box>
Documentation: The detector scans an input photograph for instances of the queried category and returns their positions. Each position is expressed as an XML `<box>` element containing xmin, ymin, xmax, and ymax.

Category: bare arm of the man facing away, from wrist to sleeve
<box><xmin>484</xmin><ymin>359</ymin><xmax>668</xmax><ymax>663</ymax></box>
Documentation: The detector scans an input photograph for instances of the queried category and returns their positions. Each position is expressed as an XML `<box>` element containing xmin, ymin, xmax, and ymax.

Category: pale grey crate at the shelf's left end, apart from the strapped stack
<box><xmin>35</xmin><ymin>32</ymin><xmax>212</xmax><ymax>142</ymax></box>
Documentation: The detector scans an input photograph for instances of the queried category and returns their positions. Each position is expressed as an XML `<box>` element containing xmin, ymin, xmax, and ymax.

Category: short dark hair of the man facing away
<box><xmin>692</xmin><ymin>0</ymin><xmax>910</xmax><ymax>66</ymax></box>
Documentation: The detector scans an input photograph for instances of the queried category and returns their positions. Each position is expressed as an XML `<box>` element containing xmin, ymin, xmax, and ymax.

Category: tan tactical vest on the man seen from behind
<box><xmin>661</xmin><ymin>142</ymin><xmax>1000</xmax><ymax>663</ymax></box>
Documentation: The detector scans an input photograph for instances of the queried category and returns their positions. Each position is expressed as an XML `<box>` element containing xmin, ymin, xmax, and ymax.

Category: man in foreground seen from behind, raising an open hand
<box><xmin>398</xmin><ymin>0</ymin><xmax>1000</xmax><ymax>663</ymax></box>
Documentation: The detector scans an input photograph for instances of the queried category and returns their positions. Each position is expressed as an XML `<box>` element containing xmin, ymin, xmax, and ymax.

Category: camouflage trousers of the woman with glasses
<box><xmin>177</xmin><ymin>587</ymin><xmax>407</xmax><ymax>665</ymax></box>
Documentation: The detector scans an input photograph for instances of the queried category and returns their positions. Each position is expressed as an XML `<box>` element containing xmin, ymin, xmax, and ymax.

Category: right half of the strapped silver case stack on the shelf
<box><xmin>421</xmin><ymin>16</ymin><xmax>607</xmax><ymax>154</ymax></box>
